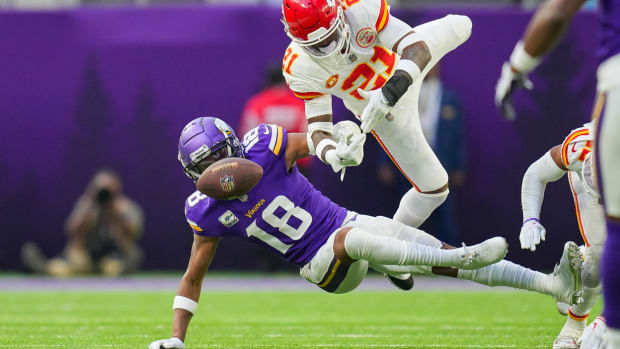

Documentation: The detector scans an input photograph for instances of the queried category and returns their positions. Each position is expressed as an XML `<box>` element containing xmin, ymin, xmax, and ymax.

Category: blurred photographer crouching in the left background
<box><xmin>22</xmin><ymin>169</ymin><xmax>144</xmax><ymax>277</ymax></box>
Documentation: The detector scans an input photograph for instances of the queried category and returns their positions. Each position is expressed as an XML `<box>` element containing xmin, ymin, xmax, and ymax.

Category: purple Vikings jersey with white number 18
<box><xmin>185</xmin><ymin>124</ymin><xmax>347</xmax><ymax>266</ymax></box>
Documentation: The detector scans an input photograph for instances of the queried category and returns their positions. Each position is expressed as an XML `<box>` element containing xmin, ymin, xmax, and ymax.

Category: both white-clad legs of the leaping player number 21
<box><xmin>373</xmin><ymin>15</ymin><xmax>472</xmax><ymax>227</ymax></box>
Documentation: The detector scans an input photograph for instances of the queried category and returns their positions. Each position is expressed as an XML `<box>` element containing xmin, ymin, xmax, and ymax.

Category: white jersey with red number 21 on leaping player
<box><xmin>282</xmin><ymin>0</ymin><xmax>400</xmax><ymax>116</ymax></box>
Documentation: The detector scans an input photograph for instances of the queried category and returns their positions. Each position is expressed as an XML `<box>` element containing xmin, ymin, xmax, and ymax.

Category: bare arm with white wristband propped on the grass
<box><xmin>149</xmin><ymin>234</ymin><xmax>219</xmax><ymax>349</ymax></box>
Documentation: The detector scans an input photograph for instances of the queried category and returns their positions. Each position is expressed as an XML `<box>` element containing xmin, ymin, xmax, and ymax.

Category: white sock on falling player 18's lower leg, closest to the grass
<box><xmin>457</xmin><ymin>260</ymin><xmax>555</xmax><ymax>295</ymax></box>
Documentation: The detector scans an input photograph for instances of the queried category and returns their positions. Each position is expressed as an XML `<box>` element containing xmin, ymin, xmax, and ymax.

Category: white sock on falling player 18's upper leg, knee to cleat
<box><xmin>344</xmin><ymin>228</ymin><xmax>463</xmax><ymax>267</ymax></box>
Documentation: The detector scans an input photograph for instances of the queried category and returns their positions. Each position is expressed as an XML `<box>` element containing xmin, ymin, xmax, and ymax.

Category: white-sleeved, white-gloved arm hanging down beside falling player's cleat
<box><xmin>519</xmin><ymin>145</ymin><xmax>568</xmax><ymax>251</ymax></box>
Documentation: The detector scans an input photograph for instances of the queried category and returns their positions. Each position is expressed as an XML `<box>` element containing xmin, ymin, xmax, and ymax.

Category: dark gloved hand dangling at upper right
<box><xmin>495</xmin><ymin>62</ymin><xmax>534</xmax><ymax>121</ymax></box>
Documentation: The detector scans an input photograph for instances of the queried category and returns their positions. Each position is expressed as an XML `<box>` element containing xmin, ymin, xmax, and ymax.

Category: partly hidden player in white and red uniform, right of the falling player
<box><xmin>519</xmin><ymin>122</ymin><xmax>607</xmax><ymax>349</ymax></box>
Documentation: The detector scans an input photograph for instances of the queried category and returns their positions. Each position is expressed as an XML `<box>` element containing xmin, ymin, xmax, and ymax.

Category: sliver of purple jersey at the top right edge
<box><xmin>598</xmin><ymin>0</ymin><xmax>620</xmax><ymax>62</ymax></box>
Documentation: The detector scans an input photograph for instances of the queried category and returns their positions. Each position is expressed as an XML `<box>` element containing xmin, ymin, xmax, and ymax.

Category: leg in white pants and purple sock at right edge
<box><xmin>596</xmin><ymin>86</ymin><xmax>620</xmax><ymax>349</ymax></box>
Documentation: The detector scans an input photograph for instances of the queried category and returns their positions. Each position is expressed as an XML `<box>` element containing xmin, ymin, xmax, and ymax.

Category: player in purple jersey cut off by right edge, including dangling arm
<box><xmin>495</xmin><ymin>0</ymin><xmax>620</xmax><ymax>349</ymax></box>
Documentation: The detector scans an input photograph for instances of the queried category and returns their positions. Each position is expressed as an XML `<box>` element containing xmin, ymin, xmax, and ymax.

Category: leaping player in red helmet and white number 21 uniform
<box><xmin>282</xmin><ymin>0</ymin><xmax>472</xmax><ymax>278</ymax></box>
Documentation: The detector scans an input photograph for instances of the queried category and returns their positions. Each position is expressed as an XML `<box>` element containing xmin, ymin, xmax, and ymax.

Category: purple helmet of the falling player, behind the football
<box><xmin>179</xmin><ymin>117</ymin><xmax>243</xmax><ymax>182</ymax></box>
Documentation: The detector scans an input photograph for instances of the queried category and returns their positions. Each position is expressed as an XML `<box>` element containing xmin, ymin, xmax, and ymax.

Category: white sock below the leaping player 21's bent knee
<box><xmin>394</xmin><ymin>188</ymin><xmax>449</xmax><ymax>228</ymax></box>
